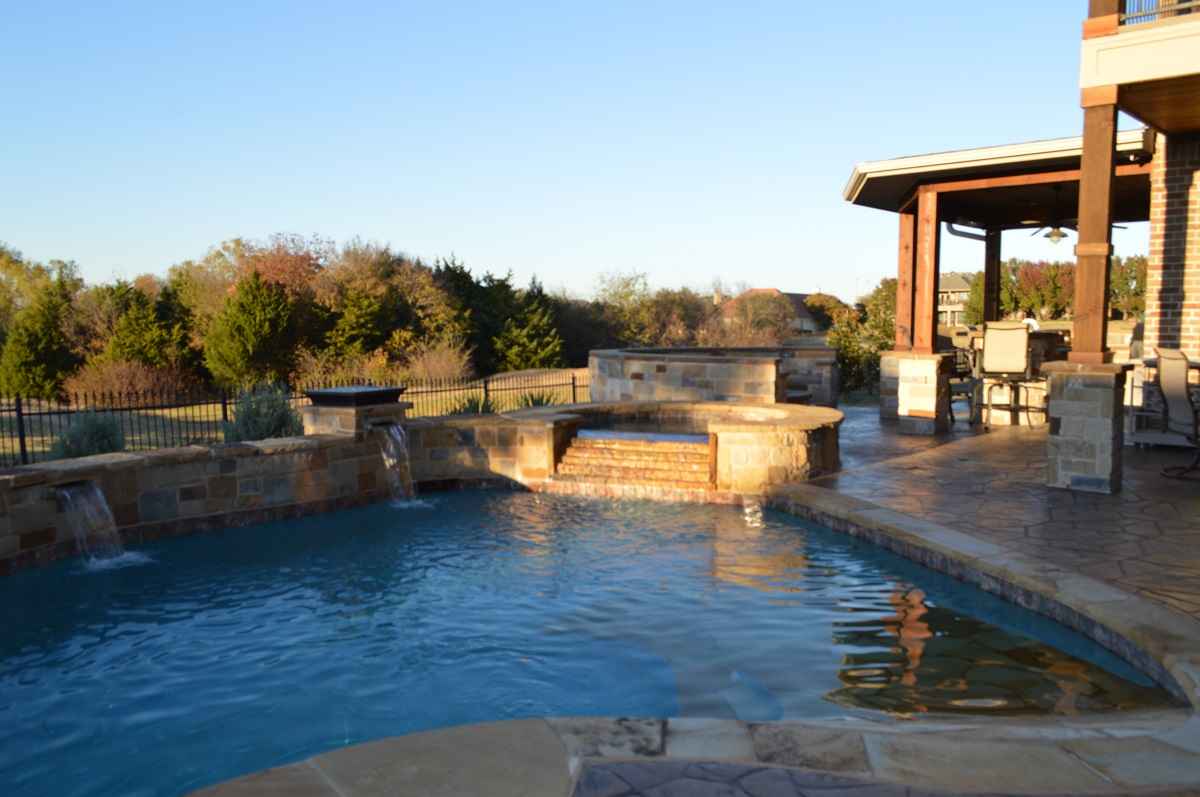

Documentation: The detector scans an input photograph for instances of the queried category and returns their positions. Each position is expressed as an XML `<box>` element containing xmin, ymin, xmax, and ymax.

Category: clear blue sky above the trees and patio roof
<box><xmin>0</xmin><ymin>0</ymin><xmax>1146</xmax><ymax>299</ymax></box>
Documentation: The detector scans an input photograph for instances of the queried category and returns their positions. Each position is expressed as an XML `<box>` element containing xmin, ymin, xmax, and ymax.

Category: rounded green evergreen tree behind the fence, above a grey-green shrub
<box><xmin>204</xmin><ymin>271</ymin><xmax>296</xmax><ymax>388</ymax></box>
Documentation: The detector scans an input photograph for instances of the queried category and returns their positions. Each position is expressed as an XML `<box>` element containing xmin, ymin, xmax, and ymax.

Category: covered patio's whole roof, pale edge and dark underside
<box><xmin>842</xmin><ymin>130</ymin><xmax>1154</xmax><ymax>229</ymax></box>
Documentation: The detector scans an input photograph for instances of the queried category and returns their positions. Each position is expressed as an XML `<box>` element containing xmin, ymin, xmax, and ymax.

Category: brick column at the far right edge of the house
<box><xmin>1145</xmin><ymin>133</ymin><xmax>1200</xmax><ymax>358</ymax></box>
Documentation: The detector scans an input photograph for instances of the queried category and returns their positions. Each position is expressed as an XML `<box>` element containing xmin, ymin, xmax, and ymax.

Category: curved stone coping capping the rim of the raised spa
<box><xmin>503</xmin><ymin>401</ymin><xmax>845</xmax><ymax>432</ymax></box>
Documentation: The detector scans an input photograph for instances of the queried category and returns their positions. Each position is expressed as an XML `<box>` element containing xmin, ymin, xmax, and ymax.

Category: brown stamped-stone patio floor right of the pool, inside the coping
<box><xmin>830</xmin><ymin>406</ymin><xmax>1200</xmax><ymax>619</ymax></box>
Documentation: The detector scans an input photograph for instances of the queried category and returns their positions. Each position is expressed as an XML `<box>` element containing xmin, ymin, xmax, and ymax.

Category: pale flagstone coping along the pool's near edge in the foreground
<box><xmin>193</xmin><ymin>712</ymin><xmax>1200</xmax><ymax>797</ymax></box>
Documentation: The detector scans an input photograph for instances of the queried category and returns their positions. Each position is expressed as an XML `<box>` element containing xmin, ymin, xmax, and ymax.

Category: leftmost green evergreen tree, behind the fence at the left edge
<box><xmin>0</xmin><ymin>275</ymin><xmax>79</xmax><ymax>399</ymax></box>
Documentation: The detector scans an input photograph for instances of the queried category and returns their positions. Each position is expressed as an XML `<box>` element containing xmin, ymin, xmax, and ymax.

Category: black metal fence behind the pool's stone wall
<box><xmin>0</xmin><ymin>370</ymin><xmax>588</xmax><ymax>467</ymax></box>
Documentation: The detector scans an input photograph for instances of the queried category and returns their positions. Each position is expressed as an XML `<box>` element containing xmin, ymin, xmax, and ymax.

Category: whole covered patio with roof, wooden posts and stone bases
<box><xmin>844</xmin><ymin>130</ymin><xmax>1158</xmax><ymax>493</ymax></box>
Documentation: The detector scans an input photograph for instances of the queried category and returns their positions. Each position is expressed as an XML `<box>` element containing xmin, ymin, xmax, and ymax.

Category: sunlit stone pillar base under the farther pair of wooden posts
<box><xmin>880</xmin><ymin>352</ymin><xmax>953</xmax><ymax>435</ymax></box>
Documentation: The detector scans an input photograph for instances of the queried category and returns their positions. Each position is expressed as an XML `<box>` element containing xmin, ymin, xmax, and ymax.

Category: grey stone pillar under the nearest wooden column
<box><xmin>1042</xmin><ymin>361</ymin><xmax>1132</xmax><ymax>493</ymax></box>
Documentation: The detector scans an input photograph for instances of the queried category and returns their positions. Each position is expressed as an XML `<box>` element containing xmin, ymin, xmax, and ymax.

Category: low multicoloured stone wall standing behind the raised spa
<box><xmin>588</xmin><ymin>348</ymin><xmax>839</xmax><ymax>407</ymax></box>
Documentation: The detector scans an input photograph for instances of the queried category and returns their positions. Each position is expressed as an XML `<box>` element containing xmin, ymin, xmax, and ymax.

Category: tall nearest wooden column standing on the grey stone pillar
<box><xmin>1069</xmin><ymin>96</ymin><xmax>1117</xmax><ymax>364</ymax></box>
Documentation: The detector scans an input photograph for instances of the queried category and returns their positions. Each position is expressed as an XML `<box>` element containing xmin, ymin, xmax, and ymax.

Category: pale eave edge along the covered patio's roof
<box><xmin>842</xmin><ymin>130</ymin><xmax>1153</xmax><ymax>210</ymax></box>
